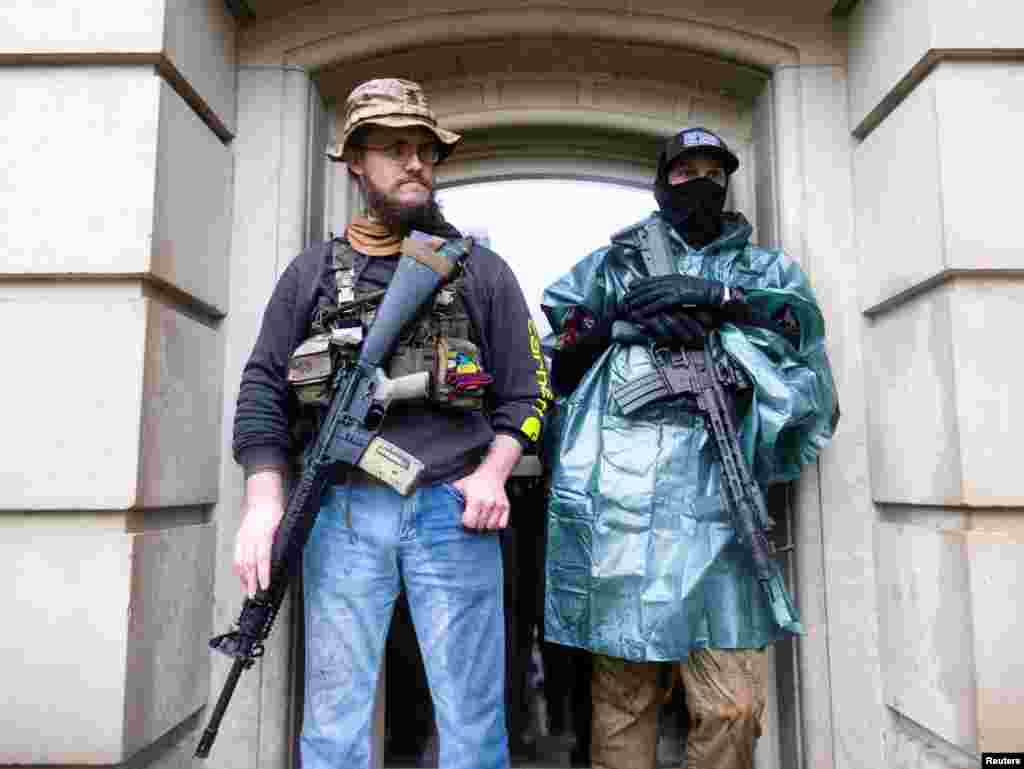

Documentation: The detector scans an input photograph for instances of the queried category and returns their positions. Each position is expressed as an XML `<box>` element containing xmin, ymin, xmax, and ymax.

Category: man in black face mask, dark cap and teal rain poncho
<box><xmin>544</xmin><ymin>128</ymin><xmax>838</xmax><ymax>769</ymax></box>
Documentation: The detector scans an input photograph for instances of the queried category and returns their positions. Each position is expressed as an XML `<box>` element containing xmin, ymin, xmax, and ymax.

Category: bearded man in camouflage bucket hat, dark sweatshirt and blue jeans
<box><xmin>233</xmin><ymin>80</ymin><xmax>549</xmax><ymax>769</ymax></box>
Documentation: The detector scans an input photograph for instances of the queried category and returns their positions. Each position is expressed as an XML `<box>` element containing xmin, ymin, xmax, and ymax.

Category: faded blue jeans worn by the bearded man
<box><xmin>300</xmin><ymin>481</ymin><xmax>509</xmax><ymax>769</ymax></box>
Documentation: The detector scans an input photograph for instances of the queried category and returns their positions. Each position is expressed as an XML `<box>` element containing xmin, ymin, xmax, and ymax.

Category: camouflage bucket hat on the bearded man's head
<box><xmin>327</xmin><ymin>78</ymin><xmax>462</xmax><ymax>161</ymax></box>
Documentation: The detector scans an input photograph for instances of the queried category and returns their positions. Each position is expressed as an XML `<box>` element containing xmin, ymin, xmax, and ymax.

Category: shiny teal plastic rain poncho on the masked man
<box><xmin>543</xmin><ymin>214</ymin><xmax>838</xmax><ymax>660</ymax></box>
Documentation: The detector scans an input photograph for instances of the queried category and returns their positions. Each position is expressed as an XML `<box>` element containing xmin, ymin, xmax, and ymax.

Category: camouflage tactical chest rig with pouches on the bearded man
<box><xmin>288</xmin><ymin>240</ymin><xmax>493</xmax><ymax>411</ymax></box>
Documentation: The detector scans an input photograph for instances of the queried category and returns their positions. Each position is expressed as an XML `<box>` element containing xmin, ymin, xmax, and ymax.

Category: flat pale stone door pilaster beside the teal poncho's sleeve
<box><xmin>772</xmin><ymin>66</ymin><xmax>885</xmax><ymax>769</ymax></box>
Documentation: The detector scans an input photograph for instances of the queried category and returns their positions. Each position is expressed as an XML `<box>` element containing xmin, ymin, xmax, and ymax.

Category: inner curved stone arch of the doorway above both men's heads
<box><xmin>315</xmin><ymin>38</ymin><xmax>800</xmax><ymax>769</ymax></box>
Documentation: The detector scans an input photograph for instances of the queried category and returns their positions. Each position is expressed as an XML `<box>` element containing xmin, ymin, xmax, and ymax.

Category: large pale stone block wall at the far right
<box><xmin>849</xmin><ymin>0</ymin><xmax>1024</xmax><ymax>769</ymax></box>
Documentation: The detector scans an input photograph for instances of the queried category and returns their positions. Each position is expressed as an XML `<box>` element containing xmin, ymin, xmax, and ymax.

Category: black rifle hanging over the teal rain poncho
<box><xmin>611</xmin><ymin>215</ymin><xmax>804</xmax><ymax>633</ymax></box>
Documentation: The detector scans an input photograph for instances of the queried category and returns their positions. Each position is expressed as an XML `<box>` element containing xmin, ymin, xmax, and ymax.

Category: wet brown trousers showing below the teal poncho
<box><xmin>591</xmin><ymin>649</ymin><xmax>767</xmax><ymax>769</ymax></box>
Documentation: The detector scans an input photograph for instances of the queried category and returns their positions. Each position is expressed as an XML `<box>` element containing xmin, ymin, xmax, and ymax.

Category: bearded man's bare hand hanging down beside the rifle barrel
<box><xmin>232</xmin><ymin>469</ymin><xmax>285</xmax><ymax>598</ymax></box>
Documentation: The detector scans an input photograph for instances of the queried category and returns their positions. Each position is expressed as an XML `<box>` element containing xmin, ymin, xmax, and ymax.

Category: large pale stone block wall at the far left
<box><xmin>0</xmin><ymin>0</ymin><xmax>236</xmax><ymax>765</ymax></box>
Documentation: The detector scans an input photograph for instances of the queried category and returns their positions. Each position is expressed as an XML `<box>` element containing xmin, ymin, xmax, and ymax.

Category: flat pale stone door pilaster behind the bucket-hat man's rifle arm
<box><xmin>202</xmin><ymin>67</ymin><xmax>326</xmax><ymax>769</ymax></box>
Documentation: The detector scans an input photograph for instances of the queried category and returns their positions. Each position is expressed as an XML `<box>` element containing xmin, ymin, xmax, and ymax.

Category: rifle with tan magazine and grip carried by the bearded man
<box><xmin>196</xmin><ymin>233</ymin><xmax>472</xmax><ymax>758</ymax></box>
